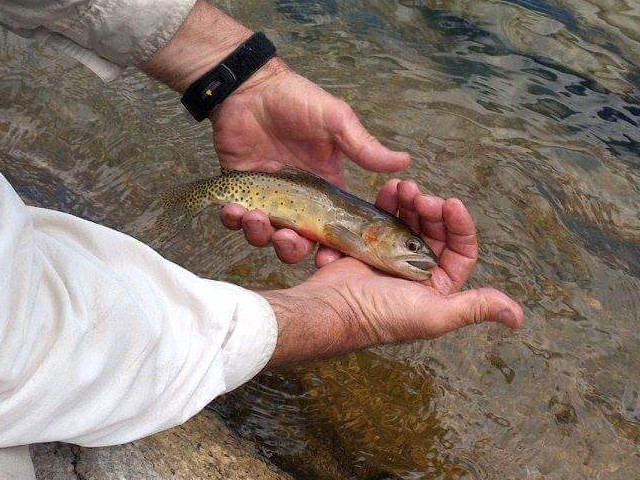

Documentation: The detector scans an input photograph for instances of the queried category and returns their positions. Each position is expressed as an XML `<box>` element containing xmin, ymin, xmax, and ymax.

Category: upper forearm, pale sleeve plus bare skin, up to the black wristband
<box><xmin>0</xmin><ymin>0</ymin><xmax>277</xmax><ymax>86</ymax></box>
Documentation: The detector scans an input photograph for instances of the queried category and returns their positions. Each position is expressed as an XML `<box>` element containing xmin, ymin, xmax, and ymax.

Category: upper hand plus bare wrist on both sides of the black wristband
<box><xmin>141</xmin><ymin>0</ymin><xmax>410</xmax><ymax>263</ymax></box>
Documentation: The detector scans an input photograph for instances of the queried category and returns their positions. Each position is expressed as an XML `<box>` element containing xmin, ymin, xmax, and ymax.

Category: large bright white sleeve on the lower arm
<box><xmin>0</xmin><ymin>175</ymin><xmax>277</xmax><ymax>447</ymax></box>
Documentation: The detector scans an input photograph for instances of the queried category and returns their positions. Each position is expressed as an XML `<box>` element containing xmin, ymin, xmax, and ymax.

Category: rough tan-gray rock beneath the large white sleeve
<box><xmin>31</xmin><ymin>410</ymin><xmax>291</xmax><ymax>480</ymax></box>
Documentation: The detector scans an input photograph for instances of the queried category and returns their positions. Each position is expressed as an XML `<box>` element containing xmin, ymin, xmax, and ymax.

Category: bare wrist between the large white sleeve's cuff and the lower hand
<box><xmin>261</xmin><ymin>286</ymin><xmax>372</xmax><ymax>368</ymax></box>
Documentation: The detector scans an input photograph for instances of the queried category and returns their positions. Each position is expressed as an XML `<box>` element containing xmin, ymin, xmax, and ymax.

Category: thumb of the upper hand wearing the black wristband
<box><xmin>329</xmin><ymin>102</ymin><xmax>411</xmax><ymax>172</ymax></box>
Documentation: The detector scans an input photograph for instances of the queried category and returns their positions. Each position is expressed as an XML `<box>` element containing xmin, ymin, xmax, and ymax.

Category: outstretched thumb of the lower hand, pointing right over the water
<box><xmin>440</xmin><ymin>288</ymin><xmax>524</xmax><ymax>333</ymax></box>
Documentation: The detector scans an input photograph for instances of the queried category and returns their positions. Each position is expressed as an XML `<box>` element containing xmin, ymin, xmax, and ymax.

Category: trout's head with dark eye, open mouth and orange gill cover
<box><xmin>363</xmin><ymin>219</ymin><xmax>438</xmax><ymax>281</ymax></box>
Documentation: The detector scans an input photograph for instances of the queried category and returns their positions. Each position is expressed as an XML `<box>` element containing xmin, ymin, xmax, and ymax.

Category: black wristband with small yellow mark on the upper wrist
<box><xmin>182</xmin><ymin>32</ymin><xmax>276</xmax><ymax>122</ymax></box>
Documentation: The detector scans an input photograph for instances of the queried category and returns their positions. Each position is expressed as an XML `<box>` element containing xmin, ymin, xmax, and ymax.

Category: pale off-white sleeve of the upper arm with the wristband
<box><xmin>0</xmin><ymin>0</ymin><xmax>196</xmax><ymax>80</ymax></box>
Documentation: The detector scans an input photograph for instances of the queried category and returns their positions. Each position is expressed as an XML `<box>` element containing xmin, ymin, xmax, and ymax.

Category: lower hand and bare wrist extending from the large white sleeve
<box><xmin>264</xmin><ymin>180</ymin><xmax>523</xmax><ymax>366</ymax></box>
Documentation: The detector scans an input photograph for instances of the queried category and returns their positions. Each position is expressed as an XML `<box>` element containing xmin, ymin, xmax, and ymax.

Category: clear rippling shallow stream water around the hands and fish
<box><xmin>0</xmin><ymin>0</ymin><xmax>640</xmax><ymax>480</ymax></box>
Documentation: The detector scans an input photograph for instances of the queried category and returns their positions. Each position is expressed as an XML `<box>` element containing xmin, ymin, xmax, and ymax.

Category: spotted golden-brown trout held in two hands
<box><xmin>161</xmin><ymin>167</ymin><xmax>437</xmax><ymax>281</ymax></box>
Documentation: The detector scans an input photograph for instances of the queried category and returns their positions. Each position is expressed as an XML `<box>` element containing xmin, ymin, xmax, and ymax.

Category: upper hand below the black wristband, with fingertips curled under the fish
<box><xmin>211</xmin><ymin>59</ymin><xmax>410</xmax><ymax>263</ymax></box>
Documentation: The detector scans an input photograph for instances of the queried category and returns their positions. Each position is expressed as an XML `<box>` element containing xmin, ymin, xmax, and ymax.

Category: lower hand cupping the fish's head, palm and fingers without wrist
<box><xmin>302</xmin><ymin>180</ymin><xmax>523</xmax><ymax>343</ymax></box>
